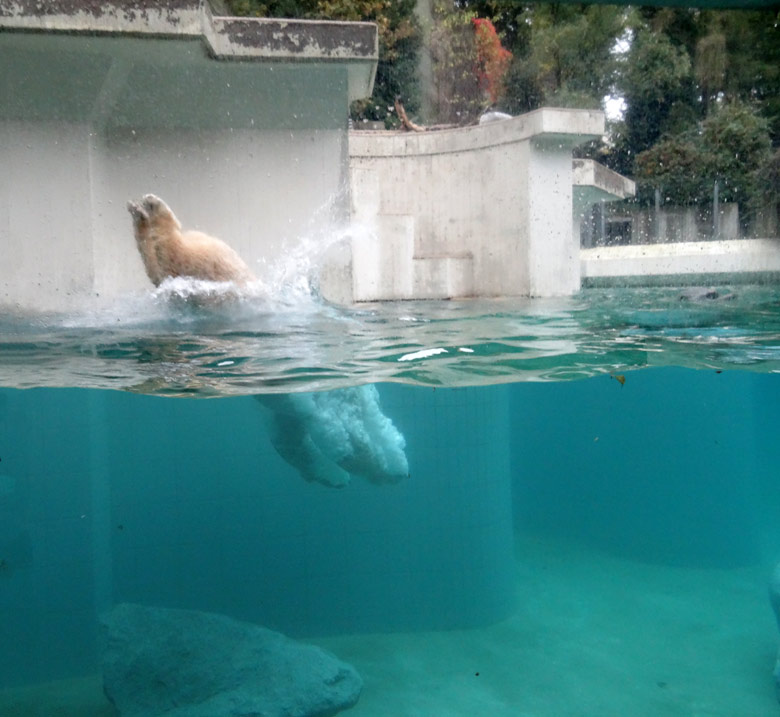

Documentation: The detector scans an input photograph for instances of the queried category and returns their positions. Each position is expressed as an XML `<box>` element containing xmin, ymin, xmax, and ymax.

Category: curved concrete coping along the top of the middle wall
<box><xmin>349</xmin><ymin>107</ymin><xmax>604</xmax><ymax>158</ymax></box>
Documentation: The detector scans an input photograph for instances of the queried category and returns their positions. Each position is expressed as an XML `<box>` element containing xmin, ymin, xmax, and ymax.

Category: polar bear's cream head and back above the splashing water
<box><xmin>127</xmin><ymin>194</ymin><xmax>255</xmax><ymax>286</ymax></box>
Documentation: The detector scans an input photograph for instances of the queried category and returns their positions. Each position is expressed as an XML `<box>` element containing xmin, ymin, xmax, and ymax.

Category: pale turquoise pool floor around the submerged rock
<box><xmin>0</xmin><ymin>535</ymin><xmax>778</xmax><ymax>717</ymax></box>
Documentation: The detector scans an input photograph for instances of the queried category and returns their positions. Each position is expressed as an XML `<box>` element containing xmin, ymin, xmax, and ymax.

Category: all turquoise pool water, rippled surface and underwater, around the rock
<box><xmin>0</xmin><ymin>287</ymin><xmax>780</xmax><ymax>716</ymax></box>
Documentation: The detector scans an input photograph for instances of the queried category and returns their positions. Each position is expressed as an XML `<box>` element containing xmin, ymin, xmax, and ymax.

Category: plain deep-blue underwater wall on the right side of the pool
<box><xmin>510</xmin><ymin>370</ymin><xmax>780</xmax><ymax>569</ymax></box>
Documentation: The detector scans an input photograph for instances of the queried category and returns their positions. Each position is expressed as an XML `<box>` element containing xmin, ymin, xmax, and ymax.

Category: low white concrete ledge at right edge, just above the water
<box><xmin>580</xmin><ymin>239</ymin><xmax>780</xmax><ymax>286</ymax></box>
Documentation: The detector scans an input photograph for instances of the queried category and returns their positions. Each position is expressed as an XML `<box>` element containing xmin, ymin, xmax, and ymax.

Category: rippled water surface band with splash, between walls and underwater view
<box><xmin>0</xmin><ymin>280</ymin><xmax>780</xmax><ymax>396</ymax></box>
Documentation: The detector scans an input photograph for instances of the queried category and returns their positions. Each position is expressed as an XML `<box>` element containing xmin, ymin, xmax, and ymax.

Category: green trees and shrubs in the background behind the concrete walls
<box><xmin>222</xmin><ymin>0</ymin><xmax>780</xmax><ymax>214</ymax></box>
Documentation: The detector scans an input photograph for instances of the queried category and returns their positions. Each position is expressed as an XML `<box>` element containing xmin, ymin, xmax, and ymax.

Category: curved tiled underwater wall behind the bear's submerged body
<box><xmin>0</xmin><ymin>385</ymin><xmax>515</xmax><ymax>685</ymax></box>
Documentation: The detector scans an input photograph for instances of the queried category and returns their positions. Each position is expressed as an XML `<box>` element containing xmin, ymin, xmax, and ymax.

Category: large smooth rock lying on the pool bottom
<box><xmin>101</xmin><ymin>604</ymin><xmax>363</xmax><ymax>717</ymax></box>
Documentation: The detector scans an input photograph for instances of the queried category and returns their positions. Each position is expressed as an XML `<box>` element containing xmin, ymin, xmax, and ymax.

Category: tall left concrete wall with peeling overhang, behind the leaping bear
<box><xmin>0</xmin><ymin>0</ymin><xmax>377</xmax><ymax>311</ymax></box>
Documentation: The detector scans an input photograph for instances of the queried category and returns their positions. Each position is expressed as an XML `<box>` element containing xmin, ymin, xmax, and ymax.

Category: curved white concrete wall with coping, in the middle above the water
<box><xmin>332</xmin><ymin>108</ymin><xmax>604</xmax><ymax>301</ymax></box>
